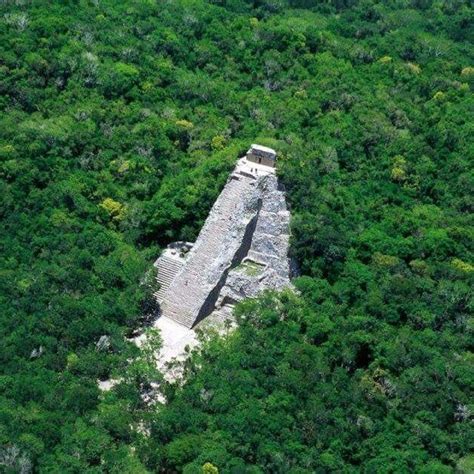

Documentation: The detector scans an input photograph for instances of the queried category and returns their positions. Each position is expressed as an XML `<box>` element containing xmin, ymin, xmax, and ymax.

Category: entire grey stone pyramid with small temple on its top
<box><xmin>155</xmin><ymin>145</ymin><xmax>290</xmax><ymax>328</ymax></box>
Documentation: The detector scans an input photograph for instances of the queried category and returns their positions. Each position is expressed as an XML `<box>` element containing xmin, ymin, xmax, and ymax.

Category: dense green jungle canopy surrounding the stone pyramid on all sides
<box><xmin>0</xmin><ymin>0</ymin><xmax>474</xmax><ymax>474</ymax></box>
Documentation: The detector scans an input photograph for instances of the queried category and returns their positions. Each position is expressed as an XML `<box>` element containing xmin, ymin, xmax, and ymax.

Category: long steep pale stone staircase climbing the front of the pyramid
<box><xmin>158</xmin><ymin>174</ymin><xmax>257</xmax><ymax>328</ymax></box>
